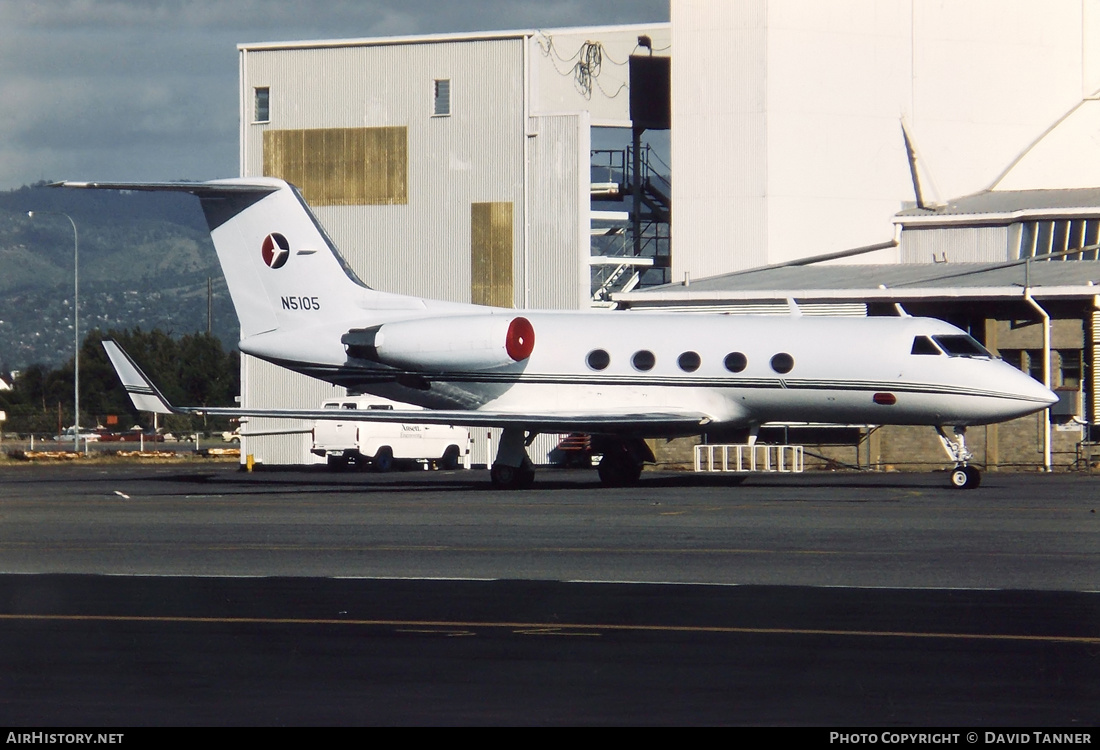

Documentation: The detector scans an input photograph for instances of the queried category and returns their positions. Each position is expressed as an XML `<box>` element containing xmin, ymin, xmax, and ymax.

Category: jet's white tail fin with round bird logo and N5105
<box><xmin>58</xmin><ymin>177</ymin><xmax>388</xmax><ymax>339</ymax></box>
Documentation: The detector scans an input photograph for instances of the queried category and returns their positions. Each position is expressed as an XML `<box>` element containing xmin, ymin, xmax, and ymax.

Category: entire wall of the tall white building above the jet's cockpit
<box><xmin>671</xmin><ymin>0</ymin><xmax>1100</xmax><ymax>280</ymax></box>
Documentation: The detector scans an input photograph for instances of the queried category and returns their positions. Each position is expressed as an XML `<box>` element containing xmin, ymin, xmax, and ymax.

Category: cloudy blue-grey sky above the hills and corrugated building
<box><xmin>0</xmin><ymin>0</ymin><xmax>669</xmax><ymax>190</ymax></box>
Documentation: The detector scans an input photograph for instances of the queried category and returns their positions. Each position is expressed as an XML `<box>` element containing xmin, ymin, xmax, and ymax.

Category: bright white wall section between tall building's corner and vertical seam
<box><xmin>766</xmin><ymin>0</ymin><xmax>912</xmax><ymax>263</ymax></box>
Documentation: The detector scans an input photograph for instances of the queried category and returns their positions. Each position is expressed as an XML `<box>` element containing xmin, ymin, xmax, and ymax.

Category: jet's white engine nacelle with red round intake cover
<box><xmin>341</xmin><ymin>315</ymin><xmax>535</xmax><ymax>372</ymax></box>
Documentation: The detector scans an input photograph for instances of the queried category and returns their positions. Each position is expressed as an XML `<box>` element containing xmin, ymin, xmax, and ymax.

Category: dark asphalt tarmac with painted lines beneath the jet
<box><xmin>0</xmin><ymin>464</ymin><xmax>1100</xmax><ymax>728</ymax></box>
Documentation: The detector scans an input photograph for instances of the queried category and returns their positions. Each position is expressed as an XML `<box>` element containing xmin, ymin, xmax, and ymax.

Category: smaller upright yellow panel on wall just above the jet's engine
<box><xmin>470</xmin><ymin>202</ymin><xmax>515</xmax><ymax>307</ymax></box>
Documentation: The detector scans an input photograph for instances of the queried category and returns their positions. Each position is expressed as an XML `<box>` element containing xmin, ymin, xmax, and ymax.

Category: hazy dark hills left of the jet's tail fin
<box><xmin>0</xmin><ymin>184</ymin><xmax>239</xmax><ymax>371</ymax></box>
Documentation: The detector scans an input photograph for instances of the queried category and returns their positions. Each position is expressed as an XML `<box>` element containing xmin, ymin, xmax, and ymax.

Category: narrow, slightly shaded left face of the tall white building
<box><xmin>671</xmin><ymin>0</ymin><xmax>768</xmax><ymax>282</ymax></box>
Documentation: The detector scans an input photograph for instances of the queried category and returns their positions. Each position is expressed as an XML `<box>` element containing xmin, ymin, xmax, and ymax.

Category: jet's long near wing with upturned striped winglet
<box><xmin>103</xmin><ymin>340</ymin><xmax>711</xmax><ymax>432</ymax></box>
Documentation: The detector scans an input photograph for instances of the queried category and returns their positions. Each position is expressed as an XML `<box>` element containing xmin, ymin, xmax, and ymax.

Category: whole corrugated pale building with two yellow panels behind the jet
<box><xmin>239</xmin><ymin>24</ymin><xmax>670</xmax><ymax>463</ymax></box>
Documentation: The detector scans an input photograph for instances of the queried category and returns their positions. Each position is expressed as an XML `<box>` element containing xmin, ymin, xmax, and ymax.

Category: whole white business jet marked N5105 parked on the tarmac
<box><xmin>59</xmin><ymin>178</ymin><xmax>1057</xmax><ymax>488</ymax></box>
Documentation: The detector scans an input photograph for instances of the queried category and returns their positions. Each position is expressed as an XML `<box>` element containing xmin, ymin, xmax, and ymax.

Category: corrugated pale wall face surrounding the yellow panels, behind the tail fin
<box><xmin>241</xmin><ymin>38</ymin><xmax>525</xmax><ymax>302</ymax></box>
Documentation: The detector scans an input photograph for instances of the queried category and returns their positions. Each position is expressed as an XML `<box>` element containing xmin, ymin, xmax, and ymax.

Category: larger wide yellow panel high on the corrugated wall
<box><xmin>264</xmin><ymin>125</ymin><xmax>408</xmax><ymax>206</ymax></box>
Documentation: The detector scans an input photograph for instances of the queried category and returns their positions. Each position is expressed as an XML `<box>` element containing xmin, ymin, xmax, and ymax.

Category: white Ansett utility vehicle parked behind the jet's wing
<box><xmin>311</xmin><ymin>396</ymin><xmax>470</xmax><ymax>472</ymax></box>
